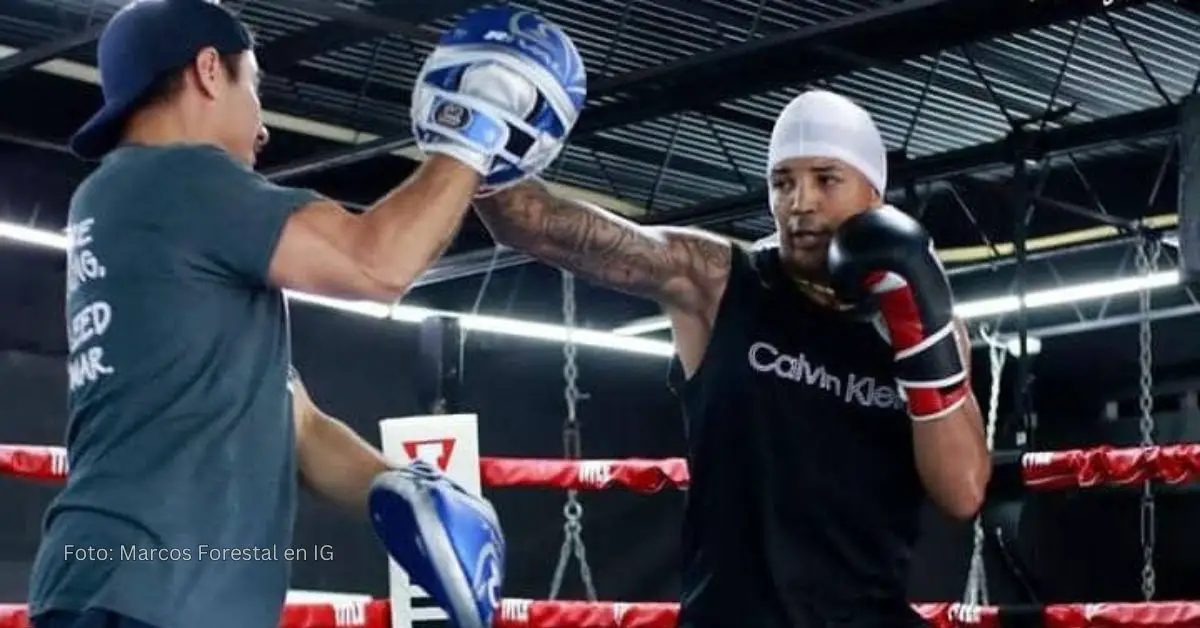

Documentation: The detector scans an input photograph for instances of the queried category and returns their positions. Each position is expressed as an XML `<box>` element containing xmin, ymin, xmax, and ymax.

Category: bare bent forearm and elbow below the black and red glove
<box><xmin>912</xmin><ymin>322</ymin><xmax>991</xmax><ymax>520</ymax></box>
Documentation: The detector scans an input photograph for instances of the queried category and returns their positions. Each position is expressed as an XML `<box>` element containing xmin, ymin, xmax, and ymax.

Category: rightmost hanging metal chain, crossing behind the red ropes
<box><xmin>1135</xmin><ymin>238</ymin><xmax>1160</xmax><ymax>602</ymax></box>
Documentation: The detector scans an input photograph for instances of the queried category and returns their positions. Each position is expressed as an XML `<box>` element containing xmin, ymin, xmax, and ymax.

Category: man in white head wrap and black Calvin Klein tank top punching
<box><xmin>475</xmin><ymin>91</ymin><xmax>990</xmax><ymax>628</ymax></box>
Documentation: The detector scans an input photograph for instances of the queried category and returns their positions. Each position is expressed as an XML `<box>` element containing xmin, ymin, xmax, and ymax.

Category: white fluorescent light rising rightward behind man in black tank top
<box><xmin>612</xmin><ymin>270</ymin><xmax>1180</xmax><ymax>336</ymax></box>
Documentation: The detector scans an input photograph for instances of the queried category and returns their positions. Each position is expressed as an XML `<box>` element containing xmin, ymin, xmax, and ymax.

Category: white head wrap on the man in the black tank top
<box><xmin>767</xmin><ymin>90</ymin><xmax>888</xmax><ymax>197</ymax></box>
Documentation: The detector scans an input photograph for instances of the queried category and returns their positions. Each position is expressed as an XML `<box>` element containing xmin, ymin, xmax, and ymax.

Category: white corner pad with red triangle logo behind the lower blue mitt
<box><xmin>379</xmin><ymin>414</ymin><xmax>482</xmax><ymax>628</ymax></box>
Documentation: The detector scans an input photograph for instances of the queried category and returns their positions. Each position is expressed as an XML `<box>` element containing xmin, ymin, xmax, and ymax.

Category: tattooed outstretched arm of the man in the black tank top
<box><xmin>476</xmin><ymin>183</ymin><xmax>731</xmax><ymax>306</ymax></box>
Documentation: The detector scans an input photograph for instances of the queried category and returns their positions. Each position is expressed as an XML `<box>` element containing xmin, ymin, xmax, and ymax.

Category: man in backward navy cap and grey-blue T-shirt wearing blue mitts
<box><xmin>29</xmin><ymin>0</ymin><xmax>586</xmax><ymax>628</ymax></box>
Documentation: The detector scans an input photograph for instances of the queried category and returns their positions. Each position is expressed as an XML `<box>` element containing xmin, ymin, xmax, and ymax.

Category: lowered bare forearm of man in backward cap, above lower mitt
<box><xmin>290</xmin><ymin>377</ymin><xmax>389</xmax><ymax>513</ymax></box>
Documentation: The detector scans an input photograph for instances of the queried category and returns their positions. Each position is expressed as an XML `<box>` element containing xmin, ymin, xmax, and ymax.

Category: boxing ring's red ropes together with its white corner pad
<box><xmin>0</xmin><ymin>414</ymin><xmax>1200</xmax><ymax>628</ymax></box>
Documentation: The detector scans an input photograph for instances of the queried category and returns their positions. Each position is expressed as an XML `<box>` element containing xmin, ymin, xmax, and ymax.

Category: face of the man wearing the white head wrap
<box><xmin>770</xmin><ymin>157</ymin><xmax>880</xmax><ymax>277</ymax></box>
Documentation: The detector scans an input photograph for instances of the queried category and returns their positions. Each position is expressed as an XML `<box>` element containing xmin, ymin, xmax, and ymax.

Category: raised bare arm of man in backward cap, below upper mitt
<box><xmin>269</xmin><ymin>155</ymin><xmax>479</xmax><ymax>301</ymax></box>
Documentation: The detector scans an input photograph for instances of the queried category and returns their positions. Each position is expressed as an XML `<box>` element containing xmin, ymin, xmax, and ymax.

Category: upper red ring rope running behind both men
<box><xmin>0</xmin><ymin>444</ymin><xmax>1200</xmax><ymax>492</ymax></box>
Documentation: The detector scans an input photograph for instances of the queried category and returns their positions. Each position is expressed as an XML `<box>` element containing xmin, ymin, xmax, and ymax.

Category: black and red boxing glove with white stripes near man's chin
<box><xmin>829</xmin><ymin>205</ymin><xmax>971</xmax><ymax>420</ymax></box>
